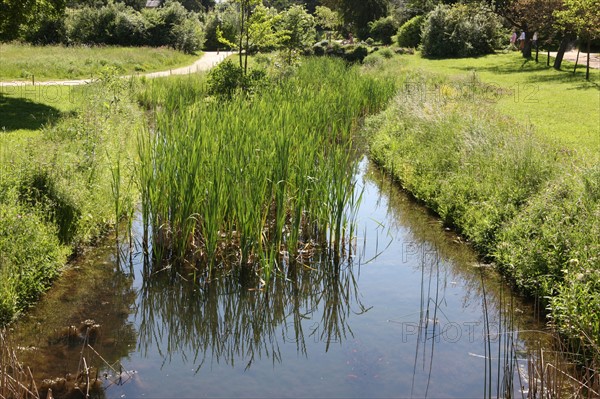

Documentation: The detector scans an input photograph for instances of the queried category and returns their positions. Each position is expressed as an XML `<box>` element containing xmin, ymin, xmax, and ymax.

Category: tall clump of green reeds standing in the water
<box><xmin>139</xmin><ymin>60</ymin><xmax>393</xmax><ymax>280</ymax></box>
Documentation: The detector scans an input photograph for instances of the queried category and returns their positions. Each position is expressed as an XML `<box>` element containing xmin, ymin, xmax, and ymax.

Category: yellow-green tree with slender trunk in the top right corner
<box><xmin>554</xmin><ymin>0</ymin><xmax>600</xmax><ymax>80</ymax></box>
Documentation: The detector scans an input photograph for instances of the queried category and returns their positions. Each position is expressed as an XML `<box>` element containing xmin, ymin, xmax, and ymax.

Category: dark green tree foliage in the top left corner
<box><xmin>0</xmin><ymin>0</ymin><xmax>65</xmax><ymax>41</ymax></box>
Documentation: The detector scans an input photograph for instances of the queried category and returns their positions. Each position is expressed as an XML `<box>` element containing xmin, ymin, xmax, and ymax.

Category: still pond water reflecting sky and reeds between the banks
<box><xmin>13</xmin><ymin>161</ymin><xmax>544</xmax><ymax>398</ymax></box>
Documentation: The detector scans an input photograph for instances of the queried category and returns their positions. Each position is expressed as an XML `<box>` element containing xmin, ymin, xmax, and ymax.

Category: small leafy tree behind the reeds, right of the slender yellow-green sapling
<box><xmin>278</xmin><ymin>6</ymin><xmax>316</xmax><ymax>64</ymax></box>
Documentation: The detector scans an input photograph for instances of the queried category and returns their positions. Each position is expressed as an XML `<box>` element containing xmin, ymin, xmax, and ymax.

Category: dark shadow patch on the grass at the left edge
<box><xmin>0</xmin><ymin>94</ymin><xmax>62</xmax><ymax>132</ymax></box>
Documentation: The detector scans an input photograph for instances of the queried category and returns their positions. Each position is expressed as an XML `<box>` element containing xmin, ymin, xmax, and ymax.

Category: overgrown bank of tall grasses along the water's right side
<box><xmin>366</xmin><ymin>56</ymin><xmax>600</xmax><ymax>350</ymax></box>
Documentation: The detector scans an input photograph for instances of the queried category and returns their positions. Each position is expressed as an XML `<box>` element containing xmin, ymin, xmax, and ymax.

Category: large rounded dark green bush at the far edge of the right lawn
<box><xmin>422</xmin><ymin>4</ymin><xmax>501</xmax><ymax>58</ymax></box>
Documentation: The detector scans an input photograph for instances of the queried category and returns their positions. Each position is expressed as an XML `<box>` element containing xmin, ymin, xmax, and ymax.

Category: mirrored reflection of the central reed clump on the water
<box><xmin>137</xmin><ymin>250</ymin><xmax>365</xmax><ymax>370</ymax></box>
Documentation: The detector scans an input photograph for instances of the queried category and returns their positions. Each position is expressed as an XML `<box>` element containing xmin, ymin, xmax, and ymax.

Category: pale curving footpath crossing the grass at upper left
<box><xmin>0</xmin><ymin>51</ymin><xmax>233</xmax><ymax>87</ymax></box>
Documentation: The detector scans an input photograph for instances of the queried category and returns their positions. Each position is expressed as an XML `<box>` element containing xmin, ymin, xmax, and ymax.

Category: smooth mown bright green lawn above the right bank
<box><xmin>404</xmin><ymin>52</ymin><xmax>600</xmax><ymax>154</ymax></box>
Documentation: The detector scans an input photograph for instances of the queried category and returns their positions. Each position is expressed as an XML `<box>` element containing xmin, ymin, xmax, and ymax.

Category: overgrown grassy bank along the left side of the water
<box><xmin>0</xmin><ymin>73</ymin><xmax>142</xmax><ymax>324</ymax></box>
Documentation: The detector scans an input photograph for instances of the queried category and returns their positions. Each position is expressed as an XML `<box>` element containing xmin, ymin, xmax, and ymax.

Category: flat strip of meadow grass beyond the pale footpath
<box><xmin>0</xmin><ymin>43</ymin><xmax>198</xmax><ymax>81</ymax></box>
